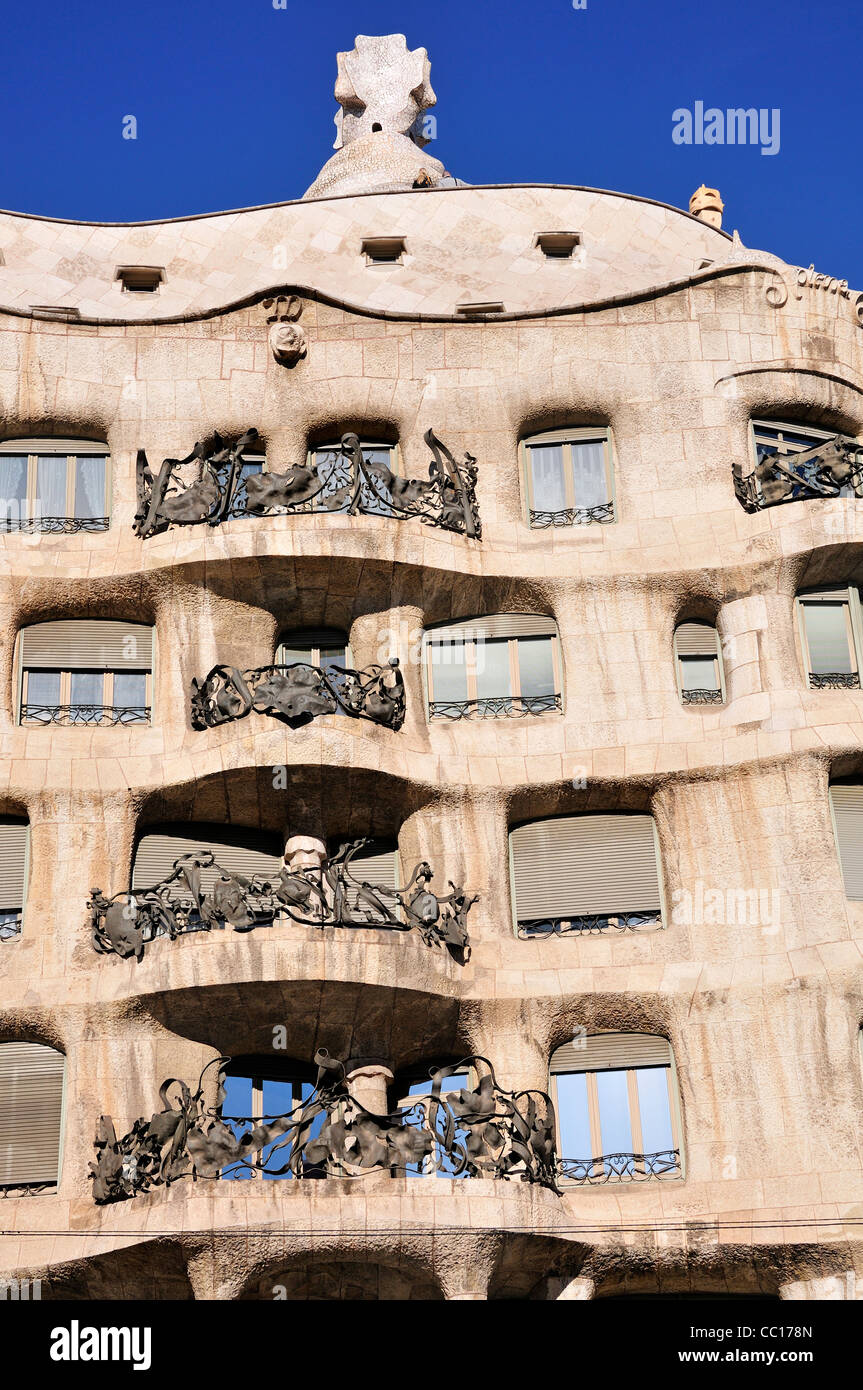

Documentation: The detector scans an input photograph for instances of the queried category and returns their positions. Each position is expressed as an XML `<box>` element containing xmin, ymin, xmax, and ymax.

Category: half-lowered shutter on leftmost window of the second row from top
<box><xmin>21</xmin><ymin>619</ymin><xmax>153</xmax><ymax>671</ymax></box>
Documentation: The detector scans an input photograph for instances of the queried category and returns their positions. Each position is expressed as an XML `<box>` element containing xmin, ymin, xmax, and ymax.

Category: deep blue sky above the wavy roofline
<box><xmin>0</xmin><ymin>0</ymin><xmax>863</xmax><ymax>289</ymax></box>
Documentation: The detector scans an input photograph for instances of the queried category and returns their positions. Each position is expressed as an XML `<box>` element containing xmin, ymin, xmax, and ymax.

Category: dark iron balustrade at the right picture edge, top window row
<box><xmin>731</xmin><ymin>434</ymin><xmax>863</xmax><ymax>512</ymax></box>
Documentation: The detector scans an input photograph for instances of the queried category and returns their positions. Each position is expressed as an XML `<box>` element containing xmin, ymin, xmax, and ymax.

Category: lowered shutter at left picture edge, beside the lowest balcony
<box><xmin>0</xmin><ymin>1043</ymin><xmax>65</xmax><ymax>1184</ymax></box>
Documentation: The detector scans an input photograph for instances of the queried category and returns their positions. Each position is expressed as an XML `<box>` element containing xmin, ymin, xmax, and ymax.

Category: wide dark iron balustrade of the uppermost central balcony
<box><xmin>133</xmin><ymin>430</ymin><xmax>482</xmax><ymax>539</ymax></box>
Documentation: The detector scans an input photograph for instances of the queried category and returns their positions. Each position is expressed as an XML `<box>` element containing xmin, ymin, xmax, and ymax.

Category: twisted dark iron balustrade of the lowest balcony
<box><xmin>89</xmin><ymin>1048</ymin><xmax>559</xmax><ymax>1204</ymax></box>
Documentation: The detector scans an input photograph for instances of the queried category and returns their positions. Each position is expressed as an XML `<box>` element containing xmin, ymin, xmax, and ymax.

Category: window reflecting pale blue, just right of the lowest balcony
<box><xmin>549</xmin><ymin>1033</ymin><xmax>682</xmax><ymax>1183</ymax></box>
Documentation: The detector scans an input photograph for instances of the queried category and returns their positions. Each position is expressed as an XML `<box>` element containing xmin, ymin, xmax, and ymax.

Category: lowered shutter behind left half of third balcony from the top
<box><xmin>132</xmin><ymin>824</ymin><xmax>282</xmax><ymax>894</ymax></box>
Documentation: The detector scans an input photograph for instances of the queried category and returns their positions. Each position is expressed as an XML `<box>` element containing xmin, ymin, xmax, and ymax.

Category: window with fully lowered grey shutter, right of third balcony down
<box><xmin>510</xmin><ymin>815</ymin><xmax>661</xmax><ymax>937</ymax></box>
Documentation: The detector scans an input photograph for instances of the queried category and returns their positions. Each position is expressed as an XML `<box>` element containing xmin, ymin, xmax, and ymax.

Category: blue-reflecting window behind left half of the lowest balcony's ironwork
<box><xmin>221</xmin><ymin>1056</ymin><xmax>319</xmax><ymax>1182</ymax></box>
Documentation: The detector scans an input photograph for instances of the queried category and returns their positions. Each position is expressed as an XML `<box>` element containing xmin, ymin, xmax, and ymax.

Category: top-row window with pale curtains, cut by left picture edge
<box><xmin>0</xmin><ymin>439</ymin><xmax>111</xmax><ymax>534</ymax></box>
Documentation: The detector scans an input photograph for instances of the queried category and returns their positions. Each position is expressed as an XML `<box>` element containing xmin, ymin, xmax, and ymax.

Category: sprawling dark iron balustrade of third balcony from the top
<box><xmin>88</xmin><ymin>840</ymin><xmax>477</xmax><ymax>963</ymax></box>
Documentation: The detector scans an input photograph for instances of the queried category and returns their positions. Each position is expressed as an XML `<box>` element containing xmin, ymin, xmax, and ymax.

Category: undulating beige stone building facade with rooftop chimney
<box><xmin>0</xmin><ymin>38</ymin><xmax>863</xmax><ymax>1300</ymax></box>
